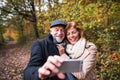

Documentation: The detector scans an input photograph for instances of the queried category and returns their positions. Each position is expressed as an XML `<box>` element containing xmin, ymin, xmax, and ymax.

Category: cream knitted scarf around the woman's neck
<box><xmin>66</xmin><ymin>38</ymin><xmax>86</xmax><ymax>59</ymax></box>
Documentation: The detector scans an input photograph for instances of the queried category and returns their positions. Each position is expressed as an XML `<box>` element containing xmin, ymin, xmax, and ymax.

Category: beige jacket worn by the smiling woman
<box><xmin>62</xmin><ymin>42</ymin><xmax>97</xmax><ymax>80</ymax></box>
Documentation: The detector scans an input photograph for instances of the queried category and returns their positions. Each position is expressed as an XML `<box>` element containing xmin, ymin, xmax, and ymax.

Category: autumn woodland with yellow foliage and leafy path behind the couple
<box><xmin>0</xmin><ymin>0</ymin><xmax>120</xmax><ymax>80</ymax></box>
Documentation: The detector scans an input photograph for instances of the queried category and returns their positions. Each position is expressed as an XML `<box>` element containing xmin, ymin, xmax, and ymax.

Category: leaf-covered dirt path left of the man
<box><xmin>0</xmin><ymin>42</ymin><xmax>32</xmax><ymax>80</ymax></box>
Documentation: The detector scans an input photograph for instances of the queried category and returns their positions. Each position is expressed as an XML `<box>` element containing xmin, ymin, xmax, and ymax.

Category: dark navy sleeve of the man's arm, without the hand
<box><xmin>24</xmin><ymin>41</ymin><xmax>44</xmax><ymax>80</ymax></box>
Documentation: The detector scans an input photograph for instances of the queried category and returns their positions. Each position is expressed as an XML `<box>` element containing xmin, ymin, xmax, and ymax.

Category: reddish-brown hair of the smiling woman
<box><xmin>65</xmin><ymin>21</ymin><xmax>85</xmax><ymax>38</ymax></box>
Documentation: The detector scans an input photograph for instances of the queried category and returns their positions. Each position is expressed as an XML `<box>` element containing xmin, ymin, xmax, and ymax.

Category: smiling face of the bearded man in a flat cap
<box><xmin>50</xmin><ymin>25</ymin><xmax>65</xmax><ymax>42</ymax></box>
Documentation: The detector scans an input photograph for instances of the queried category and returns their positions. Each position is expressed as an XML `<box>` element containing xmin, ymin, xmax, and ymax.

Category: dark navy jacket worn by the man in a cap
<box><xmin>24</xmin><ymin>34</ymin><xmax>59</xmax><ymax>80</ymax></box>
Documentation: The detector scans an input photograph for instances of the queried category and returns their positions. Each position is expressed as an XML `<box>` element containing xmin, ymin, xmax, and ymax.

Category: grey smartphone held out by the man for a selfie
<box><xmin>59</xmin><ymin>59</ymin><xmax>83</xmax><ymax>73</ymax></box>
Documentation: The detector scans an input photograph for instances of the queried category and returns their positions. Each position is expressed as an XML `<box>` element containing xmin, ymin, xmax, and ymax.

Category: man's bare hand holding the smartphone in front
<box><xmin>38</xmin><ymin>55</ymin><xmax>65</xmax><ymax>79</ymax></box>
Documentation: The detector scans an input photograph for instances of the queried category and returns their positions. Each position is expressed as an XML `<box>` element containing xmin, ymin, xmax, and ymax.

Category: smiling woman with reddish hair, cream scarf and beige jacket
<box><xmin>58</xmin><ymin>21</ymin><xmax>97</xmax><ymax>80</ymax></box>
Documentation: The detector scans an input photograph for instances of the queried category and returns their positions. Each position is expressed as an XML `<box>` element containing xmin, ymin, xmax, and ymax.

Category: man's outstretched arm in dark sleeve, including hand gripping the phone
<box><xmin>24</xmin><ymin>42</ymin><xmax>65</xmax><ymax>80</ymax></box>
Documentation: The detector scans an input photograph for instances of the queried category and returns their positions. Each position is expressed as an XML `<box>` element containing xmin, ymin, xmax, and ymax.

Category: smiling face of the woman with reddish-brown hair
<box><xmin>66</xmin><ymin>27</ymin><xmax>80</xmax><ymax>45</ymax></box>
